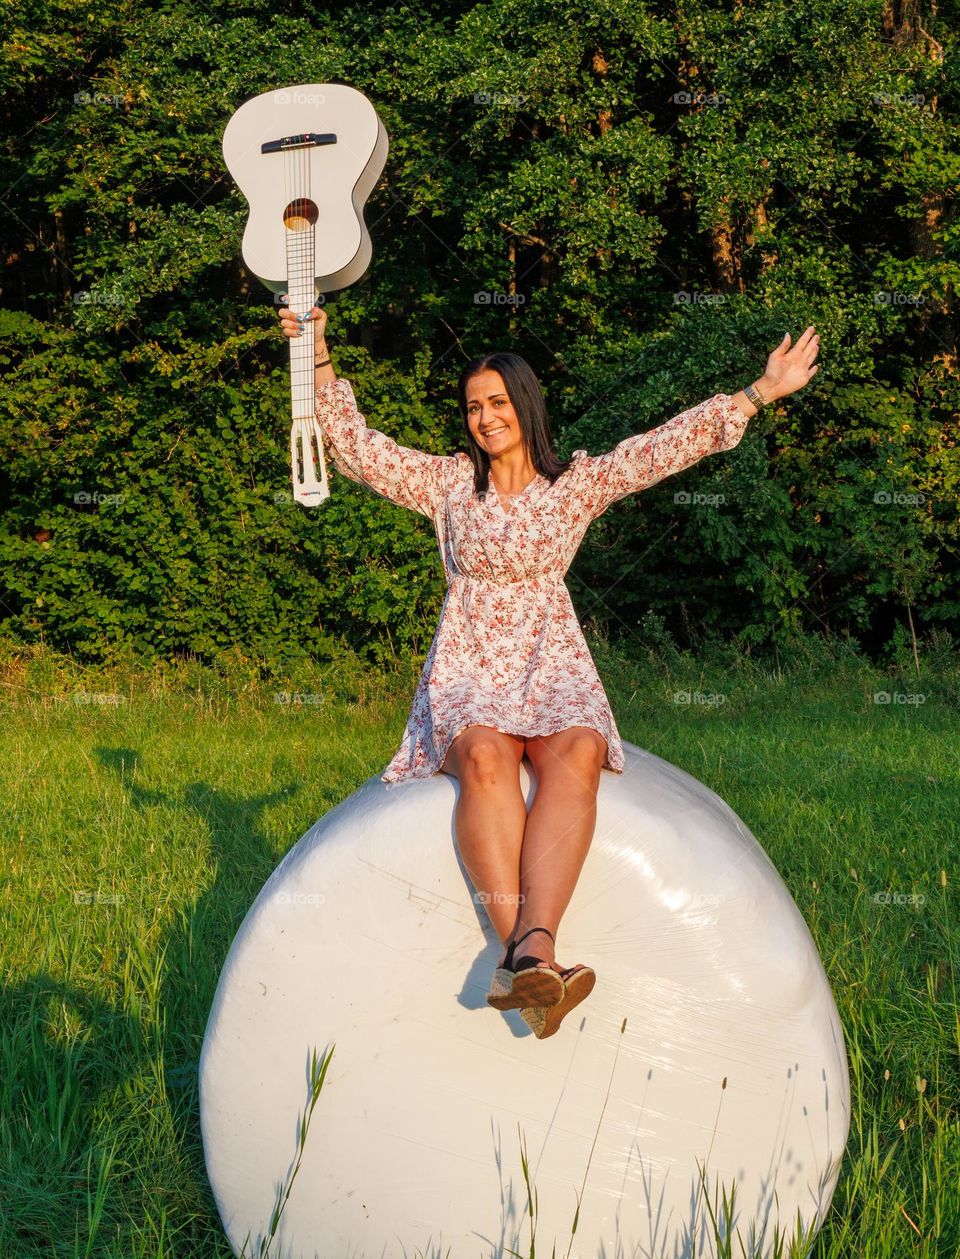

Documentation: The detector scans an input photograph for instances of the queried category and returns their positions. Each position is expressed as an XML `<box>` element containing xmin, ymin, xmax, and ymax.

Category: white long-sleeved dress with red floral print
<box><xmin>317</xmin><ymin>376</ymin><xmax>749</xmax><ymax>783</ymax></box>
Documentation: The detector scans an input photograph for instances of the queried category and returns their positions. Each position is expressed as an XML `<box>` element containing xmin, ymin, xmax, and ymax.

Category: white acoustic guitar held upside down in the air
<box><xmin>223</xmin><ymin>83</ymin><xmax>388</xmax><ymax>507</ymax></box>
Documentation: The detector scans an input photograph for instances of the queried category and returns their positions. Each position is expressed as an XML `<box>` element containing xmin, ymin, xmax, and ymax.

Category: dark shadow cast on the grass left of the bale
<box><xmin>0</xmin><ymin>747</ymin><xmax>312</xmax><ymax>1259</ymax></box>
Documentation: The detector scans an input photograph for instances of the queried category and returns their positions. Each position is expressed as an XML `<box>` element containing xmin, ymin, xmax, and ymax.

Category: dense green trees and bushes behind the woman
<box><xmin>0</xmin><ymin>0</ymin><xmax>960</xmax><ymax>661</ymax></box>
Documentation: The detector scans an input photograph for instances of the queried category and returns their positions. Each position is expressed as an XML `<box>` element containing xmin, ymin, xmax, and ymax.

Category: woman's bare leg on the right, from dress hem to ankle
<box><xmin>517</xmin><ymin>726</ymin><xmax>606</xmax><ymax>962</ymax></box>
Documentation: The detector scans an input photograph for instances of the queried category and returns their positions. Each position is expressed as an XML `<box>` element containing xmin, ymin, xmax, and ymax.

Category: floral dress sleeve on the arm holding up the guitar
<box><xmin>316</xmin><ymin>376</ymin><xmax>453</xmax><ymax>519</ymax></box>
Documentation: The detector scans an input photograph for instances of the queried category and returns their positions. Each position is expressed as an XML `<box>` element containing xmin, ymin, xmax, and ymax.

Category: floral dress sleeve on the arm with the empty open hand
<box><xmin>578</xmin><ymin>394</ymin><xmax>750</xmax><ymax>520</ymax></box>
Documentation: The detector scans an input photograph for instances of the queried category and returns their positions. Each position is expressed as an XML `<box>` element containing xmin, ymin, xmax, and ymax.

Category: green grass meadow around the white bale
<box><xmin>0</xmin><ymin>635</ymin><xmax>960</xmax><ymax>1259</ymax></box>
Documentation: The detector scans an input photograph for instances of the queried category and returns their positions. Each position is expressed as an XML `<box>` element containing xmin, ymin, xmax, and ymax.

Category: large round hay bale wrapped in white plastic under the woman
<box><xmin>200</xmin><ymin>744</ymin><xmax>849</xmax><ymax>1259</ymax></box>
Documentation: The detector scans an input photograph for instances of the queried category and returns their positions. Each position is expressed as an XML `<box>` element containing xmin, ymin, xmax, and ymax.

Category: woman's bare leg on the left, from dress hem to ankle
<box><xmin>442</xmin><ymin>725</ymin><xmax>525</xmax><ymax>961</ymax></box>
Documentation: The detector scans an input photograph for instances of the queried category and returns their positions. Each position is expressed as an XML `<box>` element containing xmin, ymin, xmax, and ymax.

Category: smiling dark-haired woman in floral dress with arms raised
<box><xmin>279</xmin><ymin>299</ymin><xmax>819</xmax><ymax>1039</ymax></box>
